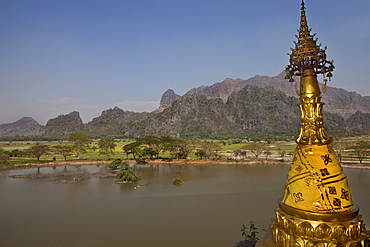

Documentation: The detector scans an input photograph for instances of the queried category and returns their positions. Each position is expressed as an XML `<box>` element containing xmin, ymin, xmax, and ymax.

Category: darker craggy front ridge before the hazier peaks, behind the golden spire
<box><xmin>122</xmin><ymin>85</ymin><xmax>370</xmax><ymax>138</ymax></box>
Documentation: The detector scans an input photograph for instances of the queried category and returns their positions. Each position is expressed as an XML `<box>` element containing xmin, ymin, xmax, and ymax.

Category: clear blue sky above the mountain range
<box><xmin>0</xmin><ymin>0</ymin><xmax>370</xmax><ymax>124</ymax></box>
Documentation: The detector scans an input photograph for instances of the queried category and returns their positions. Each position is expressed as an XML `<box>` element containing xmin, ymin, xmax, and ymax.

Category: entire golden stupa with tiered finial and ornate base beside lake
<box><xmin>262</xmin><ymin>0</ymin><xmax>370</xmax><ymax>247</ymax></box>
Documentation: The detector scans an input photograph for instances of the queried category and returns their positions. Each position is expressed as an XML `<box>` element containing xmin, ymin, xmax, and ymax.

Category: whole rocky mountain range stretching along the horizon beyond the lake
<box><xmin>0</xmin><ymin>73</ymin><xmax>370</xmax><ymax>137</ymax></box>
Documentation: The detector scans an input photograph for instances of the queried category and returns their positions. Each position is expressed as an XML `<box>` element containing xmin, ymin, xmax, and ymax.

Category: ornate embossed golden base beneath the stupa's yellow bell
<box><xmin>260</xmin><ymin>204</ymin><xmax>370</xmax><ymax>247</ymax></box>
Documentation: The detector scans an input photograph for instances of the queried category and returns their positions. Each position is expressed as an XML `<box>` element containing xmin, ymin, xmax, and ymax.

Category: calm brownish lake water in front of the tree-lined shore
<box><xmin>0</xmin><ymin>165</ymin><xmax>370</xmax><ymax>247</ymax></box>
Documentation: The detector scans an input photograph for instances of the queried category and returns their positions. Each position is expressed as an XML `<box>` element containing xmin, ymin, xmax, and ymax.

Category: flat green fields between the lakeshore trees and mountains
<box><xmin>0</xmin><ymin>138</ymin><xmax>369</xmax><ymax>167</ymax></box>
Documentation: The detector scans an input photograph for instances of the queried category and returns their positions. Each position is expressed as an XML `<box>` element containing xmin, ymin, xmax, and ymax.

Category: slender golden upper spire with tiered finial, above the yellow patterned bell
<box><xmin>285</xmin><ymin>0</ymin><xmax>334</xmax><ymax>145</ymax></box>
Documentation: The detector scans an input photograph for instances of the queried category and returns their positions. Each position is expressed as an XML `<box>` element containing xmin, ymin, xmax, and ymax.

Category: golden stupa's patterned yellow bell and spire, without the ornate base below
<box><xmin>282</xmin><ymin>1</ymin><xmax>354</xmax><ymax>219</ymax></box>
